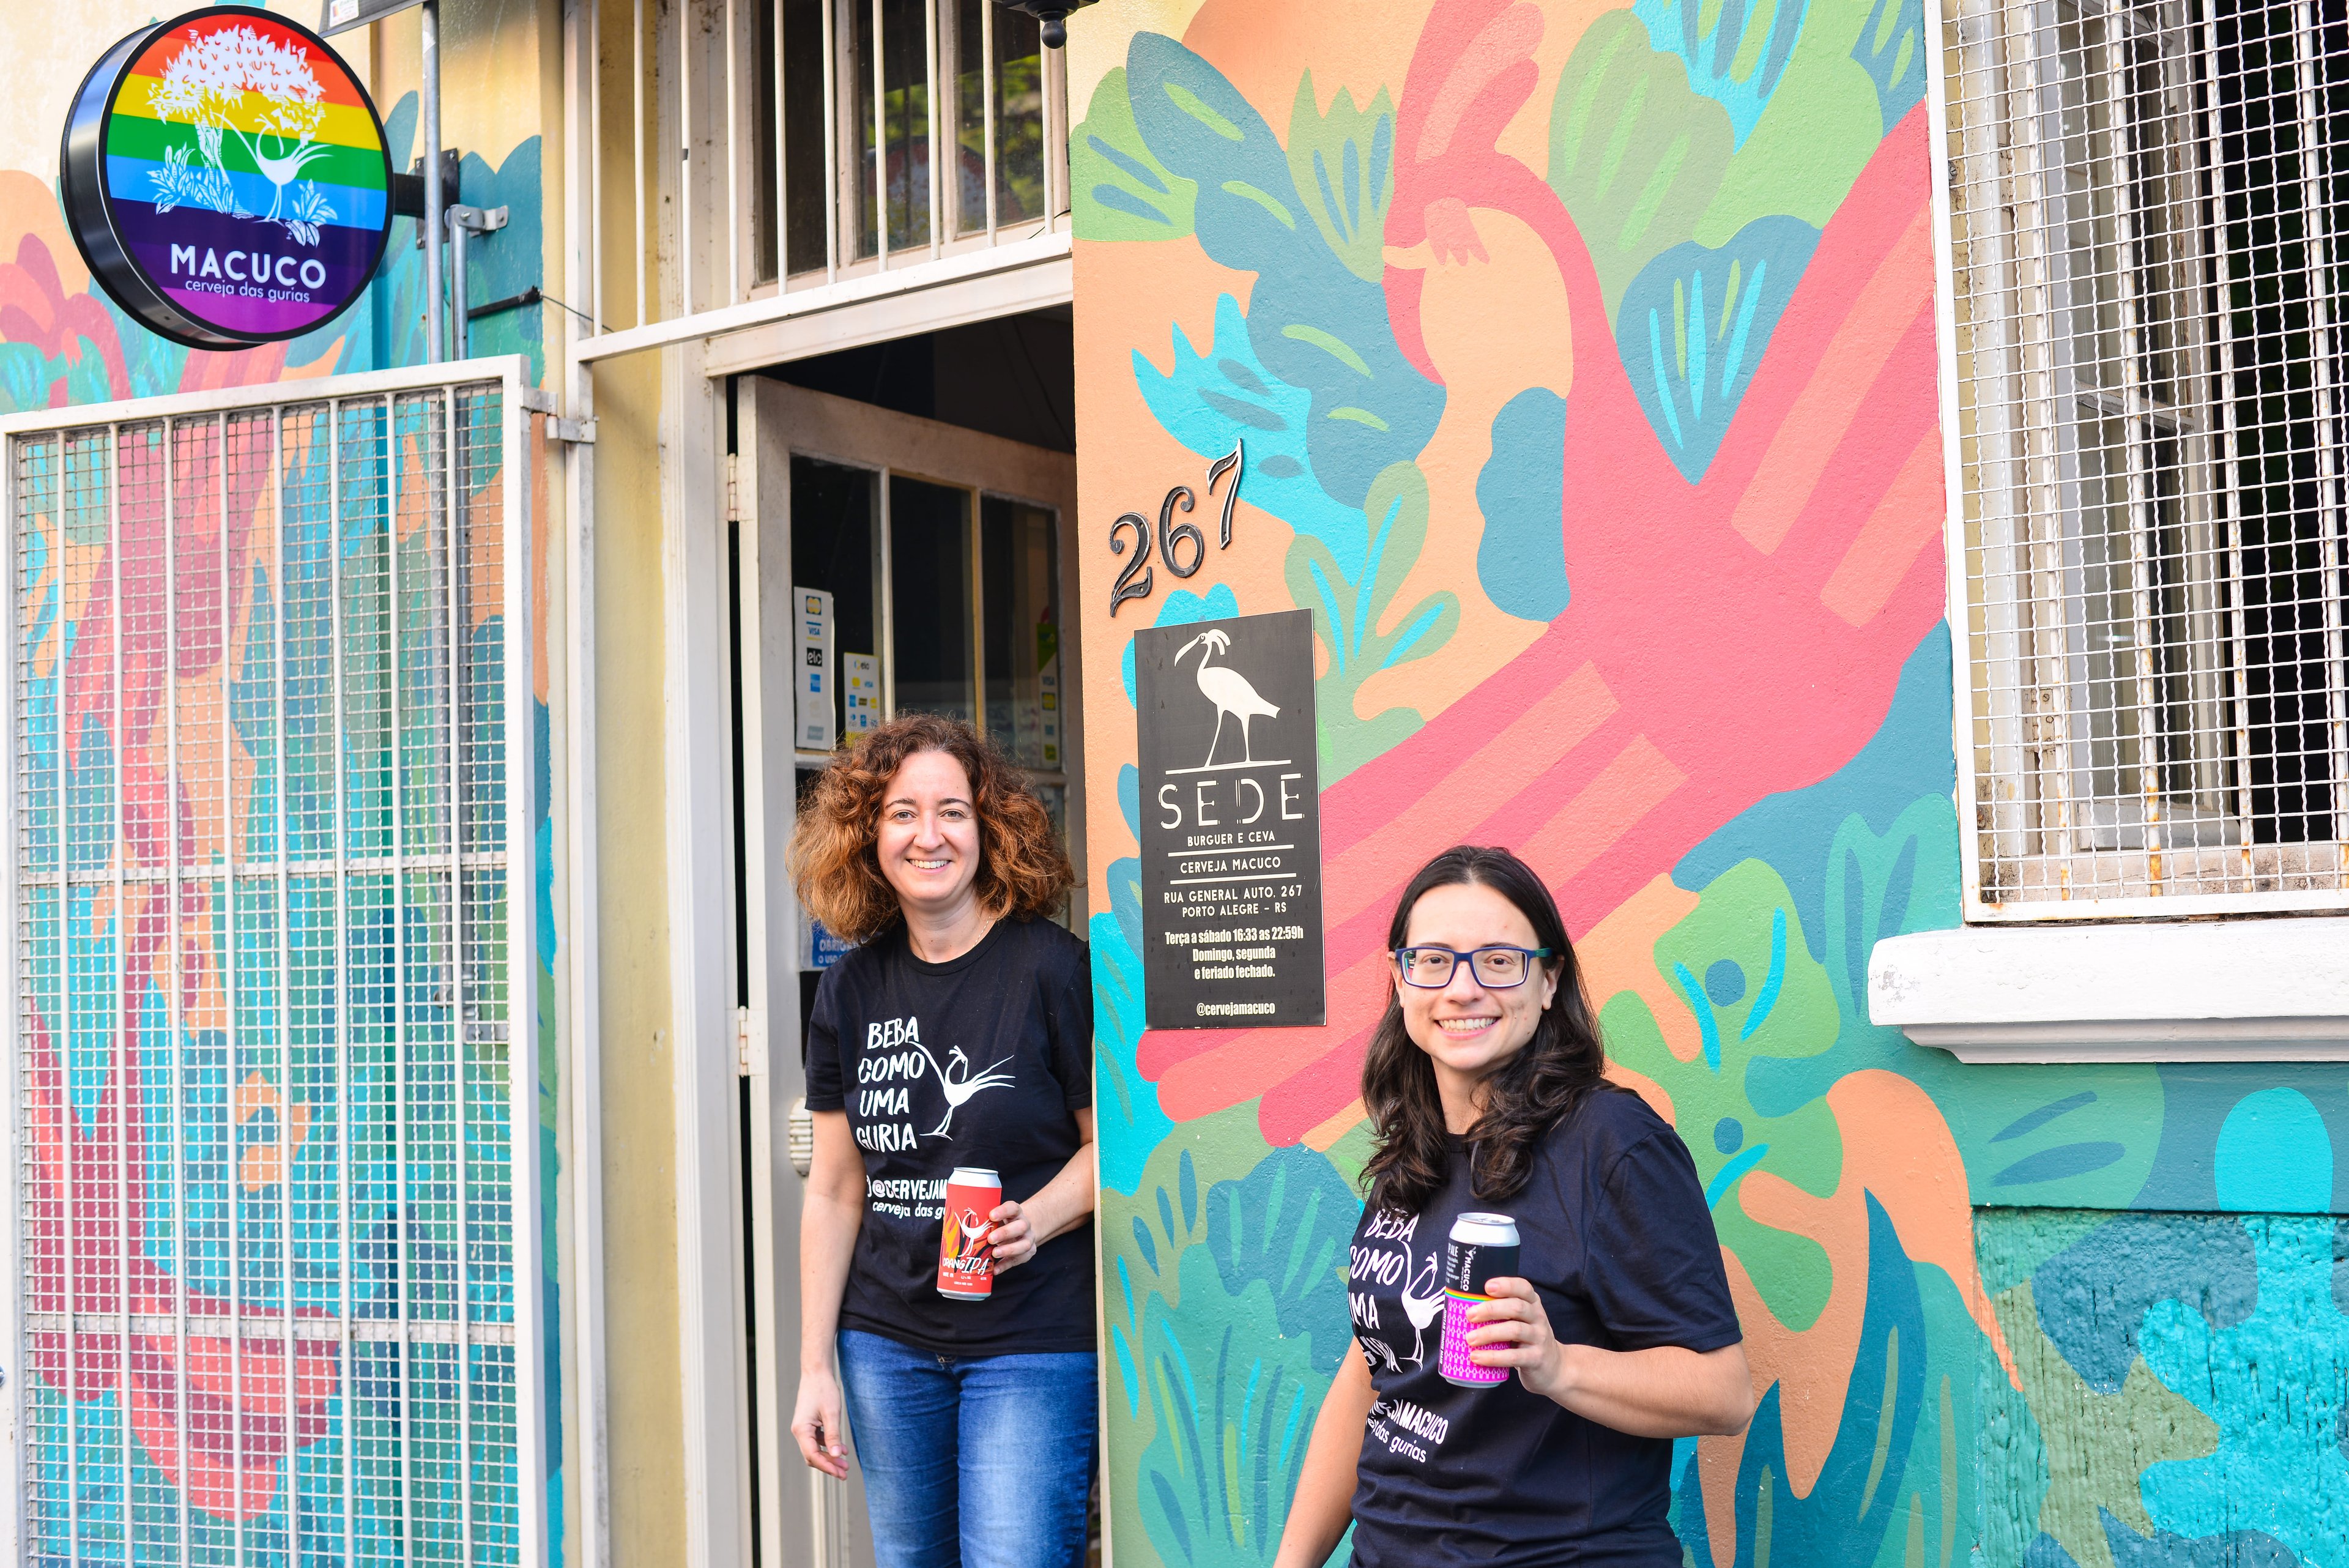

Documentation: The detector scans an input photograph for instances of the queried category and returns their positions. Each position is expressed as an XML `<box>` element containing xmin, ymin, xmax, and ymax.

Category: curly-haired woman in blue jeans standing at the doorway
<box><xmin>792</xmin><ymin>715</ymin><xmax>1097</xmax><ymax>1568</ymax></box>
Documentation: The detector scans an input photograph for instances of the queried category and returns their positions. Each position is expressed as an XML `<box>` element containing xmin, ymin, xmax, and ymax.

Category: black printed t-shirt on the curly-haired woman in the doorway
<box><xmin>808</xmin><ymin>919</ymin><xmax>1093</xmax><ymax>1356</ymax></box>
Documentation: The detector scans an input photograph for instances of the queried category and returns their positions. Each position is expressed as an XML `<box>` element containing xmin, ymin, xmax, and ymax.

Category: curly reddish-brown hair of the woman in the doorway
<box><xmin>787</xmin><ymin>712</ymin><xmax>1076</xmax><ymax>943</ymax></box>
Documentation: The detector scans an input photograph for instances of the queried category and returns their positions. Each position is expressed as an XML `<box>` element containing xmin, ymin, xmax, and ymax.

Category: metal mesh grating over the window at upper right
<box><xmin>1943</xmin><ymin>0</ymin><xmax>2349</xmax><ymax>919</ymax></box>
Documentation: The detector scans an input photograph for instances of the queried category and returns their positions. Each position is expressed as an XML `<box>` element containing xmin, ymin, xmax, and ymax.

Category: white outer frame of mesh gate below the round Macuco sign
<box><xmin>0</xmin><ymin>355</ymin><xmax>547</xmax><ymax>1566</ymax></box>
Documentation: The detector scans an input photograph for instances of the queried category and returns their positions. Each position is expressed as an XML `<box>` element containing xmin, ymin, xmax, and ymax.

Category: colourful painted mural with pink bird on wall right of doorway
<box><xmin>1071</xmin><ymin>0</ymin><xmax>2349</xmax><ymax>1568</ymax></box>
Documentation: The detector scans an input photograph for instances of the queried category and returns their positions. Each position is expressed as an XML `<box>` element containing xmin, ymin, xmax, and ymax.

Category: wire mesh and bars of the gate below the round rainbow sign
<box><xmin>7</xmin><ymin>381</ymin><xmax>536</xmax><ymax>1568</ymax></box>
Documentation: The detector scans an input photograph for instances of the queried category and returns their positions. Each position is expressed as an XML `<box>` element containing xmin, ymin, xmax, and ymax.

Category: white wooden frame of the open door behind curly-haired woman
<box><xmin>728</xmin><ymin>376</ymin><xmax>1088</xmax><ymax>1568</ymax></box>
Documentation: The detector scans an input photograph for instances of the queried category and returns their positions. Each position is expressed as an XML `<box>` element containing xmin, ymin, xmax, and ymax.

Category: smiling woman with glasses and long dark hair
<box><xmin>1275</xmin><ymin>846</ymin><xmax>1754</xmax><ymax>1568</ymax></box>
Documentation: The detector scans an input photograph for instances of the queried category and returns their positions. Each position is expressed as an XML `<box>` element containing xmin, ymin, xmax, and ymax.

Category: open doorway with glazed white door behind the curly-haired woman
<box><xmin>730</xmin><ymin>318</ymin><xmax>1085</xmax><ymax>1568</ymax></box>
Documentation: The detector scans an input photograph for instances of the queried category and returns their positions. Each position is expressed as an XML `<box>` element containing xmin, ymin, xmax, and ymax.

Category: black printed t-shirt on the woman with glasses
<box><xmin>1348</xmin><ymin>1088</ymin><xmax>1740</xmax><ymax>1568</ymax></box>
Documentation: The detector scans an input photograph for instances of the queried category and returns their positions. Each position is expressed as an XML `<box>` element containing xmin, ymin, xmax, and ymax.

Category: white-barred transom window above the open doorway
<box><xmin>606</xmin><ymin>0</ymin><xmax>1069</xmax><ymax>332</ymax></box>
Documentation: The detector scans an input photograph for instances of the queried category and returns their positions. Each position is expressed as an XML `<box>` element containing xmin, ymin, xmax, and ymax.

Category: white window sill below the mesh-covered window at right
<box><xmin>1868</xmin><ymin>917</ymin><xmax>2349</xmax><ymax>1063</ymax></box>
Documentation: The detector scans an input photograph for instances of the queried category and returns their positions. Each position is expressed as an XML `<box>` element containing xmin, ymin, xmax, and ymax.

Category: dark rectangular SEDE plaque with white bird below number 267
<box><xmin>1135</xmin><ymin>609</ymin><xmax>1325</xmax><ymax>1030</ymax></box>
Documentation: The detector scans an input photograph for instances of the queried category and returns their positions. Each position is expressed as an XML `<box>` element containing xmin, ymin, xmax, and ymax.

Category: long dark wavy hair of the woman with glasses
<box><xmin>1362</xmin><ymin>844</ymin><xmax>1614</xmax><ymax>1208</ymax></box>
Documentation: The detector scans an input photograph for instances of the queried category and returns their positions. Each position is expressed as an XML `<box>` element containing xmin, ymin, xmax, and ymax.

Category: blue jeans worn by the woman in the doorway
<box><xmin>841</xmin><ymin>1328</ymin><xmax>1099</xmax><ymax>1568</ymax></box>
